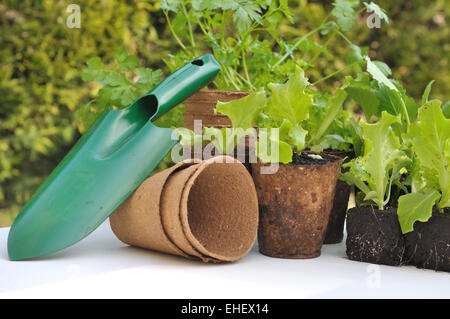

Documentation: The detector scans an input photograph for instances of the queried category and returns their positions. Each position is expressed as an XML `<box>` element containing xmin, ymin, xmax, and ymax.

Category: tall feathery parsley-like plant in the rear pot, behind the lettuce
<box><xmin>161</xmin><ymin>0</ymin><xmax>388</xmax><ymax>91</ymax></box>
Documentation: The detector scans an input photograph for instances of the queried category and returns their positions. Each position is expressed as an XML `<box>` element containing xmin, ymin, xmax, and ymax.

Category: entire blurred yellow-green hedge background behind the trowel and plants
<box><xmin>0</xmin><ymin>0</ymin><xmax>450</xmax><ymax>227</ymax></box>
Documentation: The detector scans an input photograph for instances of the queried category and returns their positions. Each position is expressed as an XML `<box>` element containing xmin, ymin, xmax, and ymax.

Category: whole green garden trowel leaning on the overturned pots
<box><xmin>8</xmin><ymin>54</ymin><xmax>220</xmax><ymax>260</ymax></box>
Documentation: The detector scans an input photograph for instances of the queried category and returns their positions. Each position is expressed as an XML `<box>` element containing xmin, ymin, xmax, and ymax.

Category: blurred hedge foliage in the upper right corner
<box><xmin>342</xmin><ymin>0</ymin><xmax>450</xmax><ymax>103</ymax></box>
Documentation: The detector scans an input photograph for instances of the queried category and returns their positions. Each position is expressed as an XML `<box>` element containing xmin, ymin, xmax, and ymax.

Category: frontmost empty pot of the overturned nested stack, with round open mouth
<box><xmin>180</xmin><ymin>156</ymin><xmax>258</xmax><ymax>261</ymax></box>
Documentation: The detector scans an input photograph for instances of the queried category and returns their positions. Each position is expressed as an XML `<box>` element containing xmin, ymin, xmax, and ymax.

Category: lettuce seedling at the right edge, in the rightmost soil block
<box><xmin>397</xmin><ymin>101</ymin><xmax>450</xmax><ymax>233</ymax></box>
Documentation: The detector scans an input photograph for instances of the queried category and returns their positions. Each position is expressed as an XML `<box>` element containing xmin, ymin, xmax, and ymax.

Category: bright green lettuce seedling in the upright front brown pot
<box><xmin>216</xmin><ymin>68</ymin><xmax>313</xmax><ymax>163</ymax></box>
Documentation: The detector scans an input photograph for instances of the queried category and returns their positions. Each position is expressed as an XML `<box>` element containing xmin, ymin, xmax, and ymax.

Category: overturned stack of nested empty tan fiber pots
<box><xmin>110</xmin><ymin>156</ymin><xmax>258</xmax><ymax>262</ymax></box>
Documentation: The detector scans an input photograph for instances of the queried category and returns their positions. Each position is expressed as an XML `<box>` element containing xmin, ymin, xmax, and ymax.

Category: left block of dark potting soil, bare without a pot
<box><xmin>347</xmin><ymin>206</ymin><xmax>405</xmax><ymax>266</ymax></box>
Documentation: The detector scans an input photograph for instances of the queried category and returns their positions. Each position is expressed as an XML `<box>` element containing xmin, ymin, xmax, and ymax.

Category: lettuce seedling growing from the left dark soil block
<box><xmin>342</xmin><ymin>57</ymin><xmax>422</xmax><ymax>210</ymax></box>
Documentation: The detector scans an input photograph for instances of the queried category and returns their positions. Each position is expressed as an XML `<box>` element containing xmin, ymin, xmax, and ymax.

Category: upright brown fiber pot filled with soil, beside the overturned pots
<box><xmin>252</xmin><ymin>152</ymin><xmax>342</xmax><ymax>258</ymax></box>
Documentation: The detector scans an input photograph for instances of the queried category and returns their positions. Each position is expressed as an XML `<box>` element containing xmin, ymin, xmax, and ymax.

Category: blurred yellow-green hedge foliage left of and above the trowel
<box><xmin>0</xmin><ymin>0</ymin><xmax>170</xmax><ymax>226</ymax></box>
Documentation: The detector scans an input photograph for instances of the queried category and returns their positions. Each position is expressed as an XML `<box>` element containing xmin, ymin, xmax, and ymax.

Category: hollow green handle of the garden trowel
<box><xmin>149</xmin><ymin>54</ymin><xmax>220</xmax><ymax>120</ymax></box>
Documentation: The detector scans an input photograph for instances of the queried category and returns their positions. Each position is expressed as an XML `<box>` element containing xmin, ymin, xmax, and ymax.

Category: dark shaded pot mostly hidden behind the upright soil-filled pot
<box><xmin>323</xmin><ymin>150</ymin><xmax>355</xmax><ymax>244</ymax></box>
